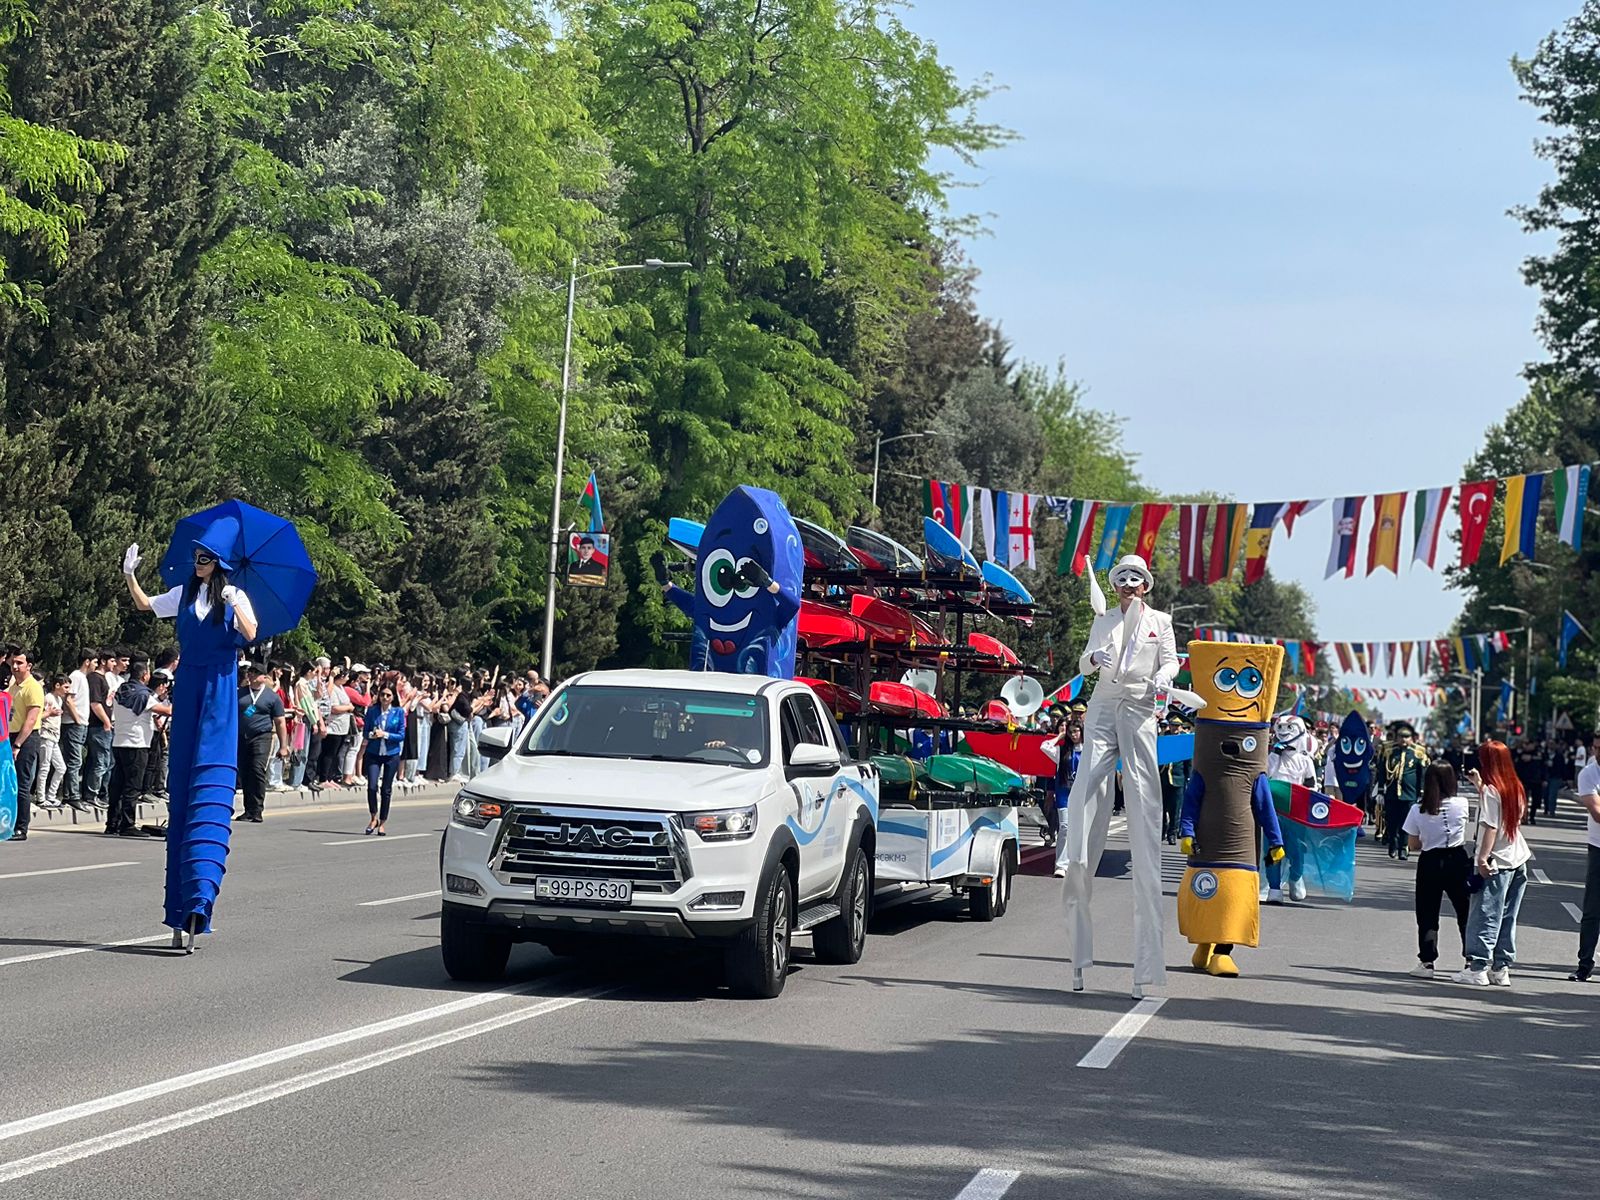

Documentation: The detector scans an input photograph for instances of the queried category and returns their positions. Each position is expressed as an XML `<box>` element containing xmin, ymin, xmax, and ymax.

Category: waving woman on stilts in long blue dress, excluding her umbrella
<box><xmin>122</xmin><ymin>517</ymin><xmax>256</xmax><ymax>950</ymax></box>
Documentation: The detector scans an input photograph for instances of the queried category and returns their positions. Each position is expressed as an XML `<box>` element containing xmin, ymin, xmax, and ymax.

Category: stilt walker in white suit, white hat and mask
<box><xmin>1062</xmin><ymin>554</ymin><xmax>1178</xmax><ymax>998</ymax></box>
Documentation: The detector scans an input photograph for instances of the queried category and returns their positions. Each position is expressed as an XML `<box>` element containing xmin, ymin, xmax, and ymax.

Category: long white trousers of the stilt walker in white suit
<box><xmin>1061</xmin><ymin>699</ymin><xmax>1166</xmax><ymax>987</ymax></box>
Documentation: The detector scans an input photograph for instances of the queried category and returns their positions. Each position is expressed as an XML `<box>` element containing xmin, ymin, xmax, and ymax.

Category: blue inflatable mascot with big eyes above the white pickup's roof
<box><xmin>656</xmin><ymin>486</ymin><xmax>805</xmax><ymax>678</ymax></box>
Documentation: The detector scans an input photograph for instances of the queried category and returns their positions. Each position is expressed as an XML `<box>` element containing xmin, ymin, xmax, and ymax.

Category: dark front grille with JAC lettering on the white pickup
<box><xmin>490</xmin><ymin>805</ymin><xmax>693</xmax><ymax>893</ymax></box>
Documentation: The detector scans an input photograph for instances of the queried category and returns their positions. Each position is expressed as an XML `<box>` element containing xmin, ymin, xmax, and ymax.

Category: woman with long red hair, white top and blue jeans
<box><xmin>1451</xmin><ymin>741</ymin><xmax>1533</xmax><ymax>987</ymax></box>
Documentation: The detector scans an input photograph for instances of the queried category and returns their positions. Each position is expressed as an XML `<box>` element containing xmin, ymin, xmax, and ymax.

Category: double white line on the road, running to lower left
<box><xmin>0</xmin><ymin>987</ymin><xmax>608</xmax><ymax>1195</ymax></box>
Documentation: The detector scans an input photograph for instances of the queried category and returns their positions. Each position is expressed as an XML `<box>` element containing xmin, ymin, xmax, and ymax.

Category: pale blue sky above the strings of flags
<box><xmin>904</xmin><ymin>0</ymin><xmax>1578</xmax><ymax>715</ymax></box>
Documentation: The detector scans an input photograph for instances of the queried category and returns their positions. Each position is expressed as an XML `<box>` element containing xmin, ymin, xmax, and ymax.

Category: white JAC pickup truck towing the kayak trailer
<box><xmin>440</xmin><ymin>670</ymin><xmax>878</xmax><ymax>997</ymax></box>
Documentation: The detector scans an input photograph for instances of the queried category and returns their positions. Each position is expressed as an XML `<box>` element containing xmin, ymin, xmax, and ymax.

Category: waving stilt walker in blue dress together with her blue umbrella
<box><xmin>122</xmin><ymin>501</ymin><xmax>317</xmax><ymax>952</ymax></box>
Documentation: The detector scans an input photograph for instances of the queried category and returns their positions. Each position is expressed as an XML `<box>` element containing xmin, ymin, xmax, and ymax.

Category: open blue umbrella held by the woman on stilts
<box><xmin>162</xmin><ymin>501</ymin><xmax>317</xmax><ymax>640</ymax></box>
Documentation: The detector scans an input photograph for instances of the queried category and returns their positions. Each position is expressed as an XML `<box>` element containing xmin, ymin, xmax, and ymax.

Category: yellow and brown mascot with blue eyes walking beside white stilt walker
<box><xmin>1178</xmin><ymin>642</ymin><xmax>1283</xmax><ymax>978</ymax></box>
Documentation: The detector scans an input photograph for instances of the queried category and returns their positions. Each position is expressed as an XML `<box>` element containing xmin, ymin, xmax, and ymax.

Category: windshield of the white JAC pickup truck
<box><xmin>520</xmin><ymin>683</ymin><xmax>768</xmax><ymax>770</ymax></box>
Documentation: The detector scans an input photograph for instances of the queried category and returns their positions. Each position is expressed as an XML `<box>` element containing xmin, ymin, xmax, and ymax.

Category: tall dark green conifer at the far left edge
<box><xmin>0</xmin><ymin>0</ymin><xmax>226</xmax><ymax>658</ymax></box>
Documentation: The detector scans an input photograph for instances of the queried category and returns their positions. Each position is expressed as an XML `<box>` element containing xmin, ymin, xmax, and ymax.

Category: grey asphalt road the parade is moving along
<box><xmin>0</xmin><ymin>797</ymin><xmax>1600</xmax><ymax>1200</ymax></box>
